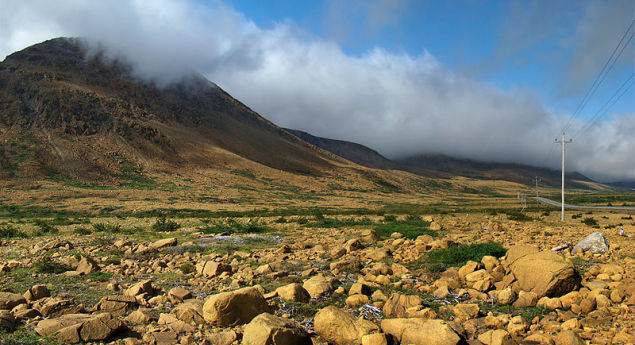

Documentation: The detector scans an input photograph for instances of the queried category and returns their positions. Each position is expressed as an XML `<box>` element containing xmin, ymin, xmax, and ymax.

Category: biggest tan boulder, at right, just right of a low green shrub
<box><xmin>505</xmin><ymin>246</ymin><xmax>581</xmax><ymax>298</ymax></box>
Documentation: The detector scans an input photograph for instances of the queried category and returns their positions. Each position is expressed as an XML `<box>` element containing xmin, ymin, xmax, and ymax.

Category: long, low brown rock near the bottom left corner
<box><xmin>35</xmin><ymin>313</ymin><xmax>123</xmax><ymax>344</ymax></box>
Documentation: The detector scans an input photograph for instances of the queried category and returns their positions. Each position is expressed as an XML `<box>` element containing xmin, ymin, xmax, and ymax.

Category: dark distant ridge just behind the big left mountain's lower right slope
<box><xmin>285</xmin><ymin>128</ymin><xmax>398</xmax><ymax>169</ymax></box>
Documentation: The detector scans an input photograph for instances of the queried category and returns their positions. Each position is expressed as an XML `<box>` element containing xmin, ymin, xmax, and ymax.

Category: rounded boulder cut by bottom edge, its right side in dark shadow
<box><xmin>242</xmin><ymin>313</ymin><xmax>311</xmax><ymax>345</ymax></box>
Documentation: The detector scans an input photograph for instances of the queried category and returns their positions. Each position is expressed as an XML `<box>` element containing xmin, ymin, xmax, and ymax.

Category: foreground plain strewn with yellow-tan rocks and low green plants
<box><xmin>0</xmin><ymin>214</ymin><xmax>635</xmax><ymax>345</ymax></box>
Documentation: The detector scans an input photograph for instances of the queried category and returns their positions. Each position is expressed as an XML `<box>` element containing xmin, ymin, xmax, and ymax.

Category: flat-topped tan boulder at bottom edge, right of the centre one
<box><xmin>381</xmin><ymin>318</ymin><xmax>462</xmax><ymax>345</ymax></box>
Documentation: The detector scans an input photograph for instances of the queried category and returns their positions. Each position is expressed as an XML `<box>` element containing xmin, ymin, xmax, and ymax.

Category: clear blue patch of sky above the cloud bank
<box><xmin>227</xmin><ymin>0</ymin><xmax>635</xmax><ymax>118</ymax></box>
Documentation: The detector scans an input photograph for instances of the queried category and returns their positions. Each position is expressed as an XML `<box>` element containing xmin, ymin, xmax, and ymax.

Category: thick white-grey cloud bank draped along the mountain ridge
<box><xmin>0</xmin><ymin>0</ymin><xmax>635</xmax><ymax>179</ymax></box>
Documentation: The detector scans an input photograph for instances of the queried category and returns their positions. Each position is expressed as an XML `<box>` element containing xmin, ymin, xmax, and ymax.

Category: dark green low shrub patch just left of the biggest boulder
<box><xmin>415</xmin><ymin>242</ymin><xmax>507</xmax><ymax>272</ymax></box>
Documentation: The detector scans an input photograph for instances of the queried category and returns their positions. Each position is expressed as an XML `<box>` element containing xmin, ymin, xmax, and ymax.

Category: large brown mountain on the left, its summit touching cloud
<box><xmin>0</xmin><ymin>38</ymin><xmax>343</xmax><ymax>181</ymax></box>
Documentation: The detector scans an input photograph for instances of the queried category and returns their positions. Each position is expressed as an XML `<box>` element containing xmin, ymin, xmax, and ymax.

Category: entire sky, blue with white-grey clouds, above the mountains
<box><xmin>0</xmin><ymin>0</ymin><xmax>635</xmax><ymax>181</ymax></box>
